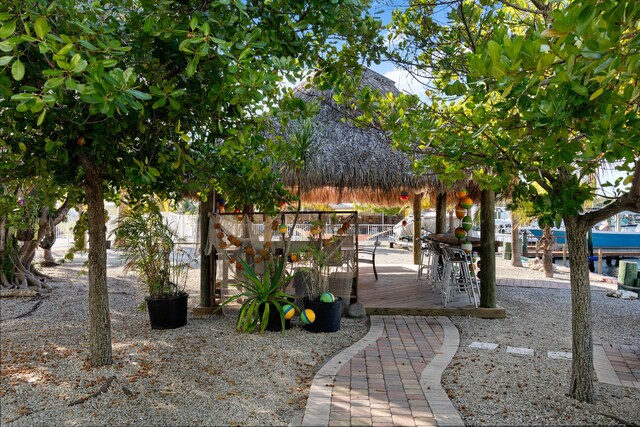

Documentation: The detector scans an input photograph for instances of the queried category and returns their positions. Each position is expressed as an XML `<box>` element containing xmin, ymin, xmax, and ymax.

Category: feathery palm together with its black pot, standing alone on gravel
<box><xmin>114</xmin><ymin>208</ymin><xmax>190</xmax><ymax>329</ymax></box>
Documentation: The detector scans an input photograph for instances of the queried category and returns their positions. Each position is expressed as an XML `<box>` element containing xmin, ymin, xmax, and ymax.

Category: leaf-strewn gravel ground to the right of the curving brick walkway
<box><xmin>442</xmin><ymin>260</ymin><xmax>640</xmax><ymax>426</ymax></box>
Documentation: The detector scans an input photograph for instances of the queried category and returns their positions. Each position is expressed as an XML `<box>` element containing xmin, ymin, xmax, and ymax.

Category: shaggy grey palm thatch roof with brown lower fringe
<box><xmin>284</xmin><ymin>68</ymin><xmax>476</xmax><ymax>206</ymax></box>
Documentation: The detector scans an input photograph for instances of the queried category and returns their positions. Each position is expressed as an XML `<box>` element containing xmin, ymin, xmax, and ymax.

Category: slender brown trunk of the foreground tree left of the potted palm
<box><xmin>79</xmin><ymin>154</ymin><xmax>113</xmax><ymax>366</ymax></box>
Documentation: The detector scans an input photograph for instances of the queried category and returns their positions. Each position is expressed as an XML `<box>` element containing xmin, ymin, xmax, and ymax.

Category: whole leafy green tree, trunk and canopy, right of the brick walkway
<box><xmin>372</xmin><ymin>0</ymin><xmax>640</xmax><ymax>402</ymax></box>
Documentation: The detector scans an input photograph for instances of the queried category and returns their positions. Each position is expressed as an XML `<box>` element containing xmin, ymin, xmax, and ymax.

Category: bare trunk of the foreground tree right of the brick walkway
<box><xmin>564</xmin><ymin>217</ymin><xmax>595</xmax><ymax>403</ymax></box>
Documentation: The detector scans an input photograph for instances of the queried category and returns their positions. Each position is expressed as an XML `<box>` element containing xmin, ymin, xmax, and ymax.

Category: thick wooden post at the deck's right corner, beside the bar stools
<box><xmin>480</xmin><ymin>190</ymin><xmax>496</xmax><ymax>308</ymax></box>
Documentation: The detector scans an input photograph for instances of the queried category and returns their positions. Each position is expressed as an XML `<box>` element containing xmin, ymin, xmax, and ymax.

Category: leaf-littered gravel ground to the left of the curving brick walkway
<box><xmin>0</xmin><ymin>254</ymin><xmax>368</xmax><ymax>426</ymax></box>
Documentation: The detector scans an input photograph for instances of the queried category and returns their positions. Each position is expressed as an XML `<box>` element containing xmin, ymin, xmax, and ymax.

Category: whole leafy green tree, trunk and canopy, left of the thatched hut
<box><xmin>0</xmin><ymin>0</ymin><xmax>379</xmax><ymax>366</ymax></box>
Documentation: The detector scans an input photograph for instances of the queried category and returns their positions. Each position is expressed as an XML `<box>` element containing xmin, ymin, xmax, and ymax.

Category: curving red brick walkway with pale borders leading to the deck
<box><xmin>302</xmin><ymin>316</ymin><xmax>463</xmax><ymax>426</ymax></box>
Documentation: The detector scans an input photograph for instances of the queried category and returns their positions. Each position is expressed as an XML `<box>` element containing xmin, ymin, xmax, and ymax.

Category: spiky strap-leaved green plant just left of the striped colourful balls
<box><xmin>222</xmin><ymin>257</ymin><xmax>299</xmax><ymax>334</ymax></box>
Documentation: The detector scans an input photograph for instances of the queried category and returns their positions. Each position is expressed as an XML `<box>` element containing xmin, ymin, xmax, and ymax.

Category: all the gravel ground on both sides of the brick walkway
<box><xmin>0</xmin><ymin>252</ymin><xmax>640</xmax><ymax>426</ymax></box>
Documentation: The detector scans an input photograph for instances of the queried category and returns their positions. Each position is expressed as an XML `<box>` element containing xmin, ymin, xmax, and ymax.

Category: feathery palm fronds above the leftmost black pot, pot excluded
<box><xmin>113</xmin><ymin>209</ymin><xmax>190</xmax><ymax>299</ymax></box>
